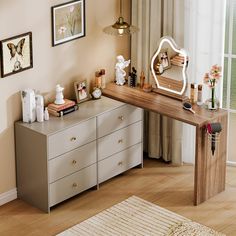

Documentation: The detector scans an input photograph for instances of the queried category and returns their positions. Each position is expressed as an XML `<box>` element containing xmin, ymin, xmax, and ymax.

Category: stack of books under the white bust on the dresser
<box><xmin>48</xmin><ymin>99</ymin><xmax>78</xmax><ymax>117</ymax></box>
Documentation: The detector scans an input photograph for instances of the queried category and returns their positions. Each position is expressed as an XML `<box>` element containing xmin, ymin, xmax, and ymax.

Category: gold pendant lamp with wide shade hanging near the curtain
<box><xmin>103</xmin><ymin>0</ymin><xmax>139</xmax><ymax>36</ymax></box>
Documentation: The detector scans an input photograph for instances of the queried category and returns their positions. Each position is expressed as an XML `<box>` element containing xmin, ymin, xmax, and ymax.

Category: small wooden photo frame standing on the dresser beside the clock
<box><xmin>74</xmin><ymin>80</ymin><xmax>90</xmax><ymax>103</ymax></box>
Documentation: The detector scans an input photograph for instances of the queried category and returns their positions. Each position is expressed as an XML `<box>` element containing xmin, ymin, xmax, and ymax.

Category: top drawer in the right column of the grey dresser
<box><xmin>97</xmin><ymin>105</ymin><xmax>142</xmax><ymax>138</ymax></box>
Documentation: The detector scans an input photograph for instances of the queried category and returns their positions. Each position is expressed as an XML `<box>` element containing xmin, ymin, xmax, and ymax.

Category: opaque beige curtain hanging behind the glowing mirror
<box><xmin>131</xmin><ymin>0</ymin><xmax>184</xmax><ymax>165</ymax></box>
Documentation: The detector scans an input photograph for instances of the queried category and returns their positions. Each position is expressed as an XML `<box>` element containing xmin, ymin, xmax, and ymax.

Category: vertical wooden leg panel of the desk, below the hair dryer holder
<box><xmin>194</xmin><ymin>115</ymin><xmax>228</xmax><ymax>205</ymax></box>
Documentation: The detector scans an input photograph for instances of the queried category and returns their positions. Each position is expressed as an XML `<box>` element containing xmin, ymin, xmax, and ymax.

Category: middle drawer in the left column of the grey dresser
<box><xmin>48</xmin><ymin>141</ymin><xmax>96</xmax><ymax>183</ymax></box>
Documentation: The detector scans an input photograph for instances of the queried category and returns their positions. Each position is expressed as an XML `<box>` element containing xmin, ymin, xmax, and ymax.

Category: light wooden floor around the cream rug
<box><xmin>0</xmin><ymin>159</ymin><xmax>236</xmax><ymax>236</ymax></box>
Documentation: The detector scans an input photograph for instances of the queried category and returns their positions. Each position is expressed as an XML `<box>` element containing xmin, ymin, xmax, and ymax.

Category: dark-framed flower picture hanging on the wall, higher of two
<box><xmin>51</xmin><ymin>0</ymin><xmax>85</xmax><ymax>47</ymax></box>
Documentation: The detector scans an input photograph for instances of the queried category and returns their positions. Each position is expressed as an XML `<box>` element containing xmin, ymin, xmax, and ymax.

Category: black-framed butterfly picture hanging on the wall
<box><xmin>0</xmin><ymin>32</ymin><xmax>33</xmax><ymax>77</ymax></box>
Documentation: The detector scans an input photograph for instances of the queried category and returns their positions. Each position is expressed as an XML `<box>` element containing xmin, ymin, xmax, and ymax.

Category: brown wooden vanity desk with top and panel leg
<box><xmin>103</xmin><ymin>83</ymin><xmax>228</xmax><ymax>205</ymax></box>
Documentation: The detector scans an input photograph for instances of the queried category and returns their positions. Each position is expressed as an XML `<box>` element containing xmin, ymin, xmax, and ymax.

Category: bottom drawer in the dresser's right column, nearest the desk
<box><xmin>98</xmin><ymin>143</ymin><xmax>142</xmax><ymax>183</ymax></box>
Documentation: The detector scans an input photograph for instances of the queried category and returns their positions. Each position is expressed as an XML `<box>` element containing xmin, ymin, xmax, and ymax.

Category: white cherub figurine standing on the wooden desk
<box><xmin>115</xmin><ymin>55</ymin><xmax>130</xmax><ymax>85</ymax></box>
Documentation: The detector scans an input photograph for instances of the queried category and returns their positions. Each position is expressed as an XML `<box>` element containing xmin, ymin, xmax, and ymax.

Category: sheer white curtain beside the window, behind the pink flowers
<box><xmin>183</xmin><ymin>0</ymin><xmax>226</xmax><ymax>163</ymax></box>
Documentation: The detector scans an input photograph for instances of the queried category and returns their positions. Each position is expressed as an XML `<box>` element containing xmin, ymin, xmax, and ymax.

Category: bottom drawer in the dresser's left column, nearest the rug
<box><xmin>49</xmin><ymin>164</ymin><xmax>97</xmax><ymax>207</ymax></box>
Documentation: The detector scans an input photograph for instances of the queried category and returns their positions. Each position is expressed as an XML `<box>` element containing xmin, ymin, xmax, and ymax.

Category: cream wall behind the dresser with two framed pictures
<box><xmin>0</xmin><ymin>0</ymin><xmax>130</xmax><ymax>194</ymax></box>
